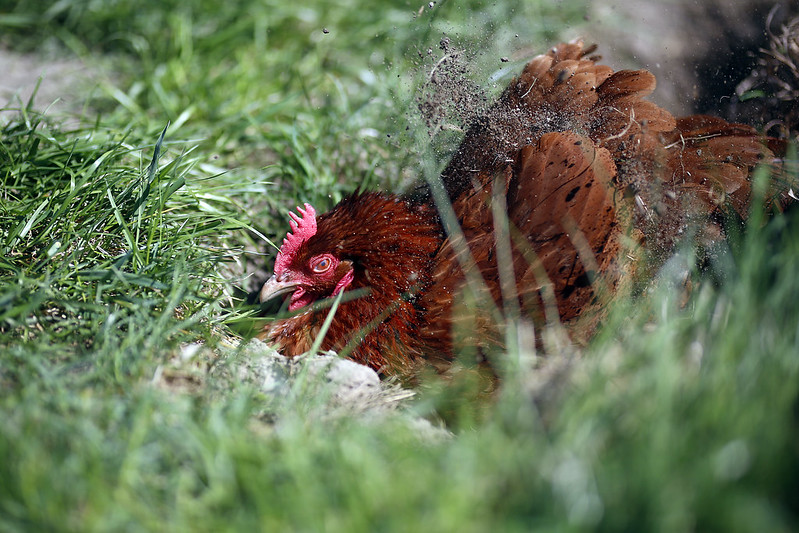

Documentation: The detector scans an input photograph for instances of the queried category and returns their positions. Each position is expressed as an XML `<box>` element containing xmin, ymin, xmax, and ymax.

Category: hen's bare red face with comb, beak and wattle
<box><xmin>260</xmin><ymin>204</ymin><xmax>354</xmax><ymax>311</ymax></box>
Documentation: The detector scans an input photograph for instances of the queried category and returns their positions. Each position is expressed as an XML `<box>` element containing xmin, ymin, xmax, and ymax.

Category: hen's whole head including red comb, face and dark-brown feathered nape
<box><xmin>261</xmin><ymin>192</ymin><xmax>442</xmax><ymax>311</ymax></box>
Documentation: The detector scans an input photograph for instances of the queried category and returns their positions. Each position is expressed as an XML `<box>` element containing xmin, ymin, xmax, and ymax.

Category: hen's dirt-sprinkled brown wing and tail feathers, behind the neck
<box><xmin>428</xmin><ymin>38</ymin><xmax>784</xmax><ymax>344</ymax></box>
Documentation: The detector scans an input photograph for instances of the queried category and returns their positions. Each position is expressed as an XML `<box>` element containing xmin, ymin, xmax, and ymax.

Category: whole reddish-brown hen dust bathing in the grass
<box><xmin>260</xmin><ymin>42</ymin><xmax>792</xmax><ymax>376</ymax></box>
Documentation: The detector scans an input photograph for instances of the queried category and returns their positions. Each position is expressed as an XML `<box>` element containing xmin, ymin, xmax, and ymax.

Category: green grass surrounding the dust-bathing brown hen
<box><xmin>0</xmin><ymin>0</ymin><xmax>799</xmax><ymax>531</ymax></box>
